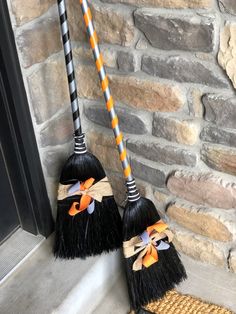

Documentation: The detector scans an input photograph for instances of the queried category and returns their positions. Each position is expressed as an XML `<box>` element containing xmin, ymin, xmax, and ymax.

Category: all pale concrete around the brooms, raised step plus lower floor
<box><xmin>0</xmin><ymin>238</ymin><xmax>236</xmax><ymax>314</ymax></box>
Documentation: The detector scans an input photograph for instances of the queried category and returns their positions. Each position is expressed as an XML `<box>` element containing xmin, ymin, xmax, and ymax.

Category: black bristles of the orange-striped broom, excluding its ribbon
<box><xmin>123</xmin><ymin>198</ymin><xmax>186</xmax><ymax>310</ymax></box>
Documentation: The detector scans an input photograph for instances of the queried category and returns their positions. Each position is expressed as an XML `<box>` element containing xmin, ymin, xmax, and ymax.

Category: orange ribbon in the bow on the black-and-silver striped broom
<box><xmin>68</xmin><ymin>178</ymin><xmax>95</xmax><ymax>216</ymax></box>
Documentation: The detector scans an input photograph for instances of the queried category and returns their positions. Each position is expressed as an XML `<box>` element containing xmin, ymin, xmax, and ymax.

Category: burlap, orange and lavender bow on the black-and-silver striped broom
<box><xmin>58</xmin><ymin>177</ymin><xmax>113</xmax><ymax>216</ymax></box>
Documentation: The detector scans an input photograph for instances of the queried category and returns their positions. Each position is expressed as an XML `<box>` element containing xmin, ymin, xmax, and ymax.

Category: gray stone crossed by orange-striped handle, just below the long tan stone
<box><xmin>84</xmin><ymin>105</ymin><xmax>148</xmax><ymax>134</ymax></box>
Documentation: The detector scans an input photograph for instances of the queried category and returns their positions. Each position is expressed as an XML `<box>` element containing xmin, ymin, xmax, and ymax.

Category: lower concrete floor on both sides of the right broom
<box><xmin>92</xmin><ymin>256</ymin><xmax>236</xmax><ymax>314</ymax></box>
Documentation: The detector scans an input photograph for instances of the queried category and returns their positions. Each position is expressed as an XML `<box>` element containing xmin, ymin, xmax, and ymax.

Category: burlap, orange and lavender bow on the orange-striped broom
<box><xmin>123</xmin><ymin>220</ymin><xmax>174</xmax><ymax>271</ymax></box>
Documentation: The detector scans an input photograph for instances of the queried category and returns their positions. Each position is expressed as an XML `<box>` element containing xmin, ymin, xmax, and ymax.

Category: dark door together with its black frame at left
<box><xmin>0</xmin><ymin>0</ymin><xmax>53</xmax><ymax>242</ymax></box>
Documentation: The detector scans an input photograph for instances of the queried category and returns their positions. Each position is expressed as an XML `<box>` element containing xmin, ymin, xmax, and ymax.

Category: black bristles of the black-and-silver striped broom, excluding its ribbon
<box><xmin>54</xmin><ymin>153</ymin><xmax>122</xmax><ymax>259</ymax></box>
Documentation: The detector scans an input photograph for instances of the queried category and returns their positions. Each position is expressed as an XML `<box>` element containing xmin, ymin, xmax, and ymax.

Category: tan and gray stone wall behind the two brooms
<box><xmin>9</xmin><ymin>0</ymin><xmax>236</xmax><ymax>272</ymax></box>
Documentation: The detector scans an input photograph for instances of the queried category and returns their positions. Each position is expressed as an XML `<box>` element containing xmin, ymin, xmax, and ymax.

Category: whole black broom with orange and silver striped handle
<box><xmin>80</xmin><ymin>0</ymin><xmax>186</xmax><ymax>310</ymax></box>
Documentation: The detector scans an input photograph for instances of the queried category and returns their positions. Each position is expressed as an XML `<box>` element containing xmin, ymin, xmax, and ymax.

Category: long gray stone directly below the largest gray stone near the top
<box><xmin>141</xmin><ymin>56</ymin><xmax>228</xmax><ymax>87</ymax></box>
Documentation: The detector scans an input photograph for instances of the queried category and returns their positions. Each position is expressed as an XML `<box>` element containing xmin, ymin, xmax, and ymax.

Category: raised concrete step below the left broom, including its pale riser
<box><xmin>0</xmin><ymin>236</ymin><xmax>121</xmax><ymax>314</ymax></box>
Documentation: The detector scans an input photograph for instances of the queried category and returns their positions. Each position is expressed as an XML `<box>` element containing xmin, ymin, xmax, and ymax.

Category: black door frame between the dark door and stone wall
<box><xmin>0</xmin><ymin>0</ymin><xmax>54</xmax><ymax>237</ymax></box>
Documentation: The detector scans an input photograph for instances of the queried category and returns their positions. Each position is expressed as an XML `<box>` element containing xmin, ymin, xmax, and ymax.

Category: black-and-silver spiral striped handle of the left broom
<box><xmin>57</xmin><ymin>0</ymin><xmax>87</xmax><ymax>154</ymax></box>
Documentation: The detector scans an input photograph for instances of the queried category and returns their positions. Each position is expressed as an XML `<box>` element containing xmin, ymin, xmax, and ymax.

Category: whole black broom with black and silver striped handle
<box><xmin>54</xmin><ymin>0</ymin><xmax>122</xmax><ymax>259</ymax></box>
